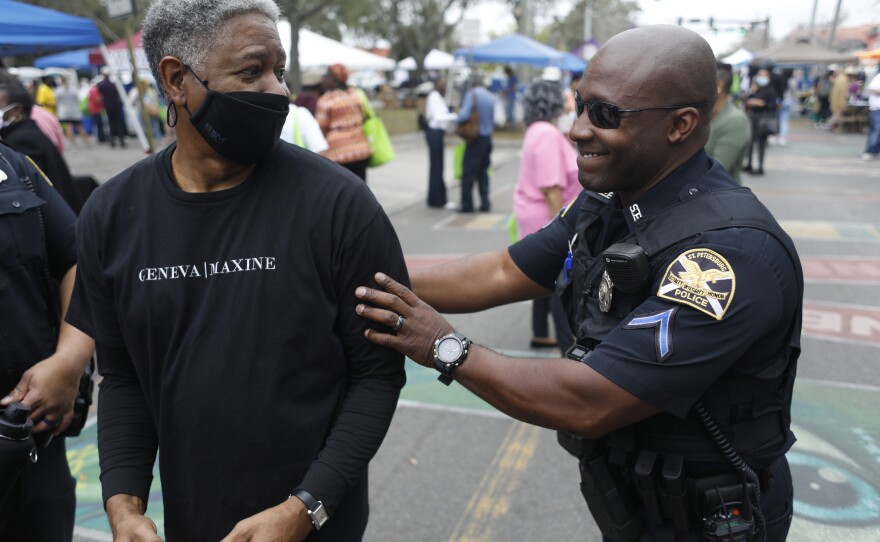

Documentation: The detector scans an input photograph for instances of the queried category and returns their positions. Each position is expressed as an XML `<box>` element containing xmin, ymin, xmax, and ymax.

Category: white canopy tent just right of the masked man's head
<box><xmin>278</xmin><ymin>19</ymin><xmax>395</xmax><ymax>71</ymax></box>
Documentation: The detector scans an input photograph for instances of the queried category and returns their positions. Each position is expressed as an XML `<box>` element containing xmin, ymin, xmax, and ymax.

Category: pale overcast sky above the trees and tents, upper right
<box><xmin>468</xmin><ymin>0</ymin><xmax>880</xmax><ymax>43</ymax></box>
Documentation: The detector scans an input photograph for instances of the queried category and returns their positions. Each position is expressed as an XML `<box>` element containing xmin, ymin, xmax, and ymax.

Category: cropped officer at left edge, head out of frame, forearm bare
<box><xmin>0</xmin><ymin>139</ymin><xmax>94</xmax><ymax>542</ymax></box>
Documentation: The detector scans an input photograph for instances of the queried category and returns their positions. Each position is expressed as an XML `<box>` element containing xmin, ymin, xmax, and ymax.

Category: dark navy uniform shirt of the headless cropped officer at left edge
<box><xmin>0</xmin><ymin>143</ymin><xmax>76</xmax><ymax>397</ymax></box>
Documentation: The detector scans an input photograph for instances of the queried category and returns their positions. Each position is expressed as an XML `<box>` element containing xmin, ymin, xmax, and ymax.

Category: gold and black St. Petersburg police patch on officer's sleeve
<box><xmin>657</xmin><ymin>248</ymin><xmax>736</xmax><ymax>320</ymax></box>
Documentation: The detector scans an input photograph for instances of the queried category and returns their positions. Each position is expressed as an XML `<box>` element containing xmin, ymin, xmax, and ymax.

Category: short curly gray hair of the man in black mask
<box><xmin>143</xmin><ymin>0</ymin><xmax>279</xmax><ymax>100</ymax></box>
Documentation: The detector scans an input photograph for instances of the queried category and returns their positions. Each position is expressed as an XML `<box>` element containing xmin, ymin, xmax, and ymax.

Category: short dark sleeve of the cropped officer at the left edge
<box><xmin>23</xmin><ymin>158</ymin><xmax>76</xmax><ymax>279</ymax></box>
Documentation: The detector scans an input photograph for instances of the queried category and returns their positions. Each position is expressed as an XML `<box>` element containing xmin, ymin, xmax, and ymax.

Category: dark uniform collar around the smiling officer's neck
<box><xmin>614</xmin><ymin>149</ymin><xmax>736</xmax><ymax>233</ymax></box>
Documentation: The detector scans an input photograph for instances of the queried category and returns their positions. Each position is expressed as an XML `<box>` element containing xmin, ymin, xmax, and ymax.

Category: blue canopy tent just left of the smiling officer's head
<box><xmin>453</xmin><ymin>34</ymin><xmax>587</xmax><ymax>71</ymax></box>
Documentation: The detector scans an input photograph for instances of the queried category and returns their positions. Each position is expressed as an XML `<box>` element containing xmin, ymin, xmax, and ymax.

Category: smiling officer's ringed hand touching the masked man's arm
<box><xmin>355</xmin><ymin>273</ymin><xmax>455</xmax><ymax>367</ymax></box>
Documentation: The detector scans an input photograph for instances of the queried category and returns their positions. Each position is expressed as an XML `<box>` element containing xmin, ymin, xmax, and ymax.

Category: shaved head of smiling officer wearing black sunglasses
<box><xmin>569</xmin><ymin>25</ymin><xmax>718</xmax><ymax>198</ymax></box>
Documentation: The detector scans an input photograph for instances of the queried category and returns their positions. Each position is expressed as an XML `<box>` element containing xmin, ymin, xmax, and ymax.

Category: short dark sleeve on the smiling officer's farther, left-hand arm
<box><xmin>507</xmin><ymin>192</ymin><xmax>587</xmax><ymax>290</ymax></box>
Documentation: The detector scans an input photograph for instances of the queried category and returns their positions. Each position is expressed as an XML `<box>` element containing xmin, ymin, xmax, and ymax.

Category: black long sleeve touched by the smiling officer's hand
<box><xmin>297</xmin><ymin>210</ymin><xmax>410</xmax><ymax>516</ymax></box>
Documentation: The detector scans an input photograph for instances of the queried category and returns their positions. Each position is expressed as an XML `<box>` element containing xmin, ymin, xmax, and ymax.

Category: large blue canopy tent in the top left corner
<box><xmin>0</xmin><ymin>0</ymin><xmax>101</xmax><ymax>56</ymax></box>
